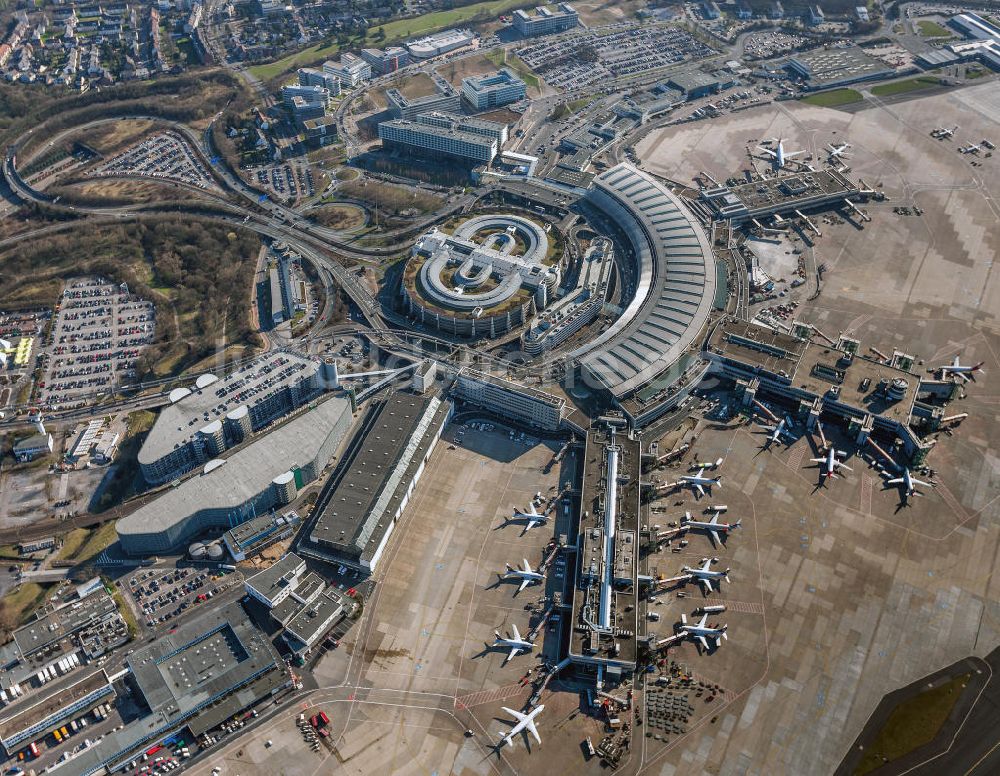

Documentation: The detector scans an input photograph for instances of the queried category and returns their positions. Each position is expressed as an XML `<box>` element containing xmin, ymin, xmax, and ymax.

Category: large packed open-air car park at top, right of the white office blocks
<box><xmin>516</xmin><ymin>23</ymin><xmax>714</xmax><ymax>90</ymax></box>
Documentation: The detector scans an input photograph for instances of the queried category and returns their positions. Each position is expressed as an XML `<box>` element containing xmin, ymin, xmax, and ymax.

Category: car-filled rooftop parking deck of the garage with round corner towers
<box><xmin>139</xmin><ymin>353</ymin><xmax>320</xmax><ymax>464</ymax></box>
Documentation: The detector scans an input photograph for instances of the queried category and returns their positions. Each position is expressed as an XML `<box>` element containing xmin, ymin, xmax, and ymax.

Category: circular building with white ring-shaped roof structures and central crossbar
<box><xmin>401</xmin><ymin>215</ymin><xmax>560</xmax><ymax>339</ymax></box>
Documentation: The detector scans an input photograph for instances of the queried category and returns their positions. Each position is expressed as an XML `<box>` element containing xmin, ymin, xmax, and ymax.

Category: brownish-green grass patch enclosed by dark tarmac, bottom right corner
<box><xmin>854</xmin><ymin>674</ymin><xmax>971</xmax><ymax>776</ymax></box>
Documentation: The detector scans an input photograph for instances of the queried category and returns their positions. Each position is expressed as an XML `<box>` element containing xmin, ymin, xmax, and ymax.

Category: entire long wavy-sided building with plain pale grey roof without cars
<box><xmin>116</xmin><ymin>397</ymin><xmax>352</xmax><ymax>555</ymax></box>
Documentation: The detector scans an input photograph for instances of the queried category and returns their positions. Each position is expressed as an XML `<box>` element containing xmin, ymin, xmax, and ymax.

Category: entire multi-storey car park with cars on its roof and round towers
<box><xmin>138</xmin><ymin>353</ymin><xmax>327</xmax><ymax>485</ymax></box>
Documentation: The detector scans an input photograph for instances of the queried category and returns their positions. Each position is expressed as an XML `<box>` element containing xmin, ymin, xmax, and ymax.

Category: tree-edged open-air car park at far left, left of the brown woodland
<box><xmin>38</xmin><ymin>278</ymin><xmax>156</xmax><ymax>406</ymax></box>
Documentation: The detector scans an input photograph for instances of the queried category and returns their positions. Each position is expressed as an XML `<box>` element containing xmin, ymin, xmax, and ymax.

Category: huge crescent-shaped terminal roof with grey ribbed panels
<box><xmin>577</xmin><ymin>164</ymin><xmax>717</xmax><ymax>398</ymax></box>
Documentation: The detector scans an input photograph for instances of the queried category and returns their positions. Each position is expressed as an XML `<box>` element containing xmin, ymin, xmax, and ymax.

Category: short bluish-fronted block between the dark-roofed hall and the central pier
<box><xmin>452</xmin><ymin>367</ymin><xmax>566</xmax><ymax>431</ymax></box>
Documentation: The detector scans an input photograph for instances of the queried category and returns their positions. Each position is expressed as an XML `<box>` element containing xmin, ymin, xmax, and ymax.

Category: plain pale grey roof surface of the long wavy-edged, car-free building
<box><xmin>117</xmin><ymin>397</ymin><xmax>351</xmax><ymax>536</ymax></box>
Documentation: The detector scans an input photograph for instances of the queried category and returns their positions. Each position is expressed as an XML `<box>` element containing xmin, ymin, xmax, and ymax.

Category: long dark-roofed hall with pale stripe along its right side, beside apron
<box><xmin>296</xmin><ymin>393</ymin><xmax>452</xmax><ymax>572</ymax></box>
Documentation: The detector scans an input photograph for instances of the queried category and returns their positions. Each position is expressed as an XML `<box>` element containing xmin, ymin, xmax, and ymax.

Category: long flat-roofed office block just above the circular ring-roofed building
<box><xmin>378</xmin><ymin>113</ymin><xmax>506</xmax><ymax>164</ymax></box>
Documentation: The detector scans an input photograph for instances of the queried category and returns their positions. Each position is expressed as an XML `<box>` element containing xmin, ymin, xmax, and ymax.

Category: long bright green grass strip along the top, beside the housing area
<box><xmin>250</xmin><ymin>0</ymin><xmax>525</xmax><ymax>81</ymax></box>
